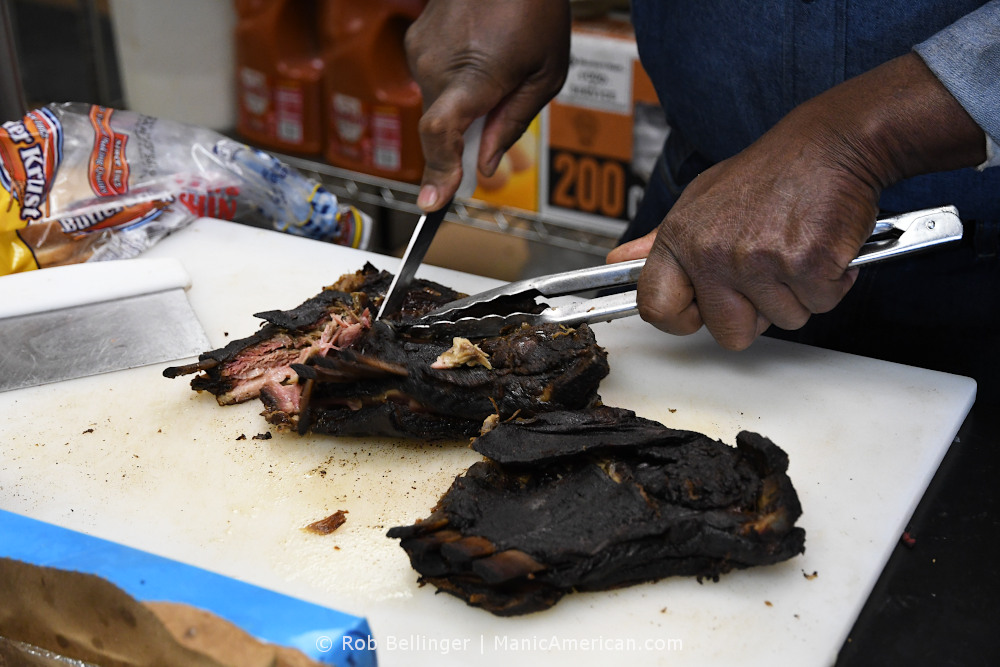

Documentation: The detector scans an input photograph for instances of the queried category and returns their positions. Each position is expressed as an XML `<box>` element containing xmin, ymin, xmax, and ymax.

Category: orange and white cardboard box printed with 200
<box><xmin>539</xmin><ymin>16</ymin><xmax>669</xmax><ymax>231</ymax></box>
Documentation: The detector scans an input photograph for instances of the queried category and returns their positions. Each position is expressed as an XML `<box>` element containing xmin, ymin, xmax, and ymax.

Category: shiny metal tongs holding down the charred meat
<box><xmin>406</xmin><ymin>206</ymin><xmax>962</xmax><ymax>338</ymax></box>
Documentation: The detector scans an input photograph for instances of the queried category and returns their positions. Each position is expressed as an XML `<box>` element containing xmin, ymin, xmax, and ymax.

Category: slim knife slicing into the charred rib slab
<box><xmin>375</xmin><ymin>117</ymin><xmax>485</xmax><ymax>320</ymax></box>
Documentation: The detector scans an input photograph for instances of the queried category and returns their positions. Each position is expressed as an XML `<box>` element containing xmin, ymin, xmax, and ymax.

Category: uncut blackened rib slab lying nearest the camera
<box><xmin>388</xmin><ymin>407</ymin><xmax>805</xmax><ymax>616</ymax></box>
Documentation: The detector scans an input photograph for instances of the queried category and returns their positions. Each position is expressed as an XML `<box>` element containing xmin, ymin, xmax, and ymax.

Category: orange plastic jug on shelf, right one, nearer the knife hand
<box><xmin>320</xmin><ymin>0</ymin><xmax>424</xmax><ymax>183</ymax></box>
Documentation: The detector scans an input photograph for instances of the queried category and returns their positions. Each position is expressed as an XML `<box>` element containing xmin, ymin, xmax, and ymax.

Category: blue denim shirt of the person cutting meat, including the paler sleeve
<box><xmin>632</xmin><ymin>0</ymin><xmax>1000</xmax><ymax>221</ymax></box>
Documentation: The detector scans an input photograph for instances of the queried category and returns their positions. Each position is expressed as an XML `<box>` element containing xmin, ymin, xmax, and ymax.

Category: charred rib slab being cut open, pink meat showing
<box><xmin>164</xmin><ymin>265</ymin><xmax>608</xmax><ymax>439</ymax></box>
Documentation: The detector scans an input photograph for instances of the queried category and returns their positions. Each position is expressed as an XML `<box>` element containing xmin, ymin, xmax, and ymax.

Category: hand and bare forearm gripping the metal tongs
<box><xmin>608</xmin><ymin>54</ymin><xmax>985</xmax><ymax>350</ymax></box>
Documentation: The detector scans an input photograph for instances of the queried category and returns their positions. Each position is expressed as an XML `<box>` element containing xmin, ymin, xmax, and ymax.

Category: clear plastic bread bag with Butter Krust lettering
<box><xmin>0</xmin><ymin>103</ymin><xmax>372</xmax><ymax>275</ymax></box>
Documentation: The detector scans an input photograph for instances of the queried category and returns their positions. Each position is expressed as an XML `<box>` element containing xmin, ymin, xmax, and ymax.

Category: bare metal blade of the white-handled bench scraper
<box><xmin>0</xmin><ymin>289</ymin><xmax>212</xmax><ymax>391</ymax></box>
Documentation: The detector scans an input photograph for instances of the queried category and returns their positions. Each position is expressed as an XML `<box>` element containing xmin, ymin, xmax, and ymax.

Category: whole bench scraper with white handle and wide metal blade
<box><xmin>0</xmin><ymin>257</ymin><xmax>211</xmax><ymax>392</ymax></box>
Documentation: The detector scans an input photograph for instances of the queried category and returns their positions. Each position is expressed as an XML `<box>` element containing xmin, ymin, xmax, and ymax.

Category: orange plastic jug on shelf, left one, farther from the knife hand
<box><xmin>235</xmin><ymin>0</ymin><xmax>323</xmax><ymax>154</ymax></box>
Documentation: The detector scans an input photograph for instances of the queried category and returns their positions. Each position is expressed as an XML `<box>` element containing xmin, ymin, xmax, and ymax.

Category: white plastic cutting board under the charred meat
<box><xmin>0</xmin><ymin>220</ymin><xmax>975</xmax><ymax>667</ymax></box>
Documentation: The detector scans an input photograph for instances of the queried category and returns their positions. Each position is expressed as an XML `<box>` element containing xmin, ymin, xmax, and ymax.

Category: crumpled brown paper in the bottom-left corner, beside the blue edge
<box><xmin>0</xmin><ymin>558</ymin><xmax>318</xmax><ymax>667</ymax></box>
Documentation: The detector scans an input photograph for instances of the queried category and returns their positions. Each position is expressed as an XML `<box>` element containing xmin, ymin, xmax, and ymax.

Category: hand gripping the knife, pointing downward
<box><xmin>406</xmin><ymin>0</ymin><xmax>570</xmax><ymax>211</ymax></box>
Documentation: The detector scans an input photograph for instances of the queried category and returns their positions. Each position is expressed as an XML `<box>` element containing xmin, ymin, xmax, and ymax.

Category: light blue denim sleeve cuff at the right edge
<box><xmin>914</xmin><ymin>0</ymin><xmax>1000</xmax><ymax>169</ymax></box>
